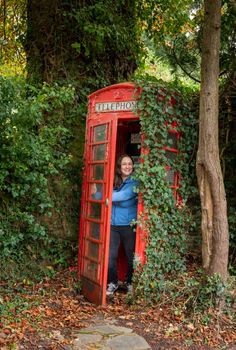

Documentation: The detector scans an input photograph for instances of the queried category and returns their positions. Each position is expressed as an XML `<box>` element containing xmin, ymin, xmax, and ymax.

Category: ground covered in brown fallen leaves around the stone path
<box><xmin>0</xmin><ymin>269</ymin><xmax>236</xmax><ymax>350</ymax></box>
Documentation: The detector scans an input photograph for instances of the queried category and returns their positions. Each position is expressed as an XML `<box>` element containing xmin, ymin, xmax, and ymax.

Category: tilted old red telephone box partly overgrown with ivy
<box><xmin>79</xmin><ymin>83</ymin><xmax>179</xmax><ymax>305</ymax></box>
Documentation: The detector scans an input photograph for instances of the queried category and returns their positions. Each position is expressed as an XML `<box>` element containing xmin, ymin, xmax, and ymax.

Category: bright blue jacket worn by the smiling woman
<box><xmin>111</xmin><ymin>177</ymin><xmax>138</xmax><ymax>226</ymax></box>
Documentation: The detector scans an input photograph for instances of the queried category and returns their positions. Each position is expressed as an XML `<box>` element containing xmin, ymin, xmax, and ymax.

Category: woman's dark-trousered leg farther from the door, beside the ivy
<box><xmin>121</xmin><ymin>226</ymin><xmax>136</xmax><ymax>284</ymax></box>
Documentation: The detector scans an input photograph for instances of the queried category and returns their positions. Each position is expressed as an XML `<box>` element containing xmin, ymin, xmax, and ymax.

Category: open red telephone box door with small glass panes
<box><xmin>79</xmin><ymin>115</ymin><xmax>117</xmax><ymax>305</ymax></box>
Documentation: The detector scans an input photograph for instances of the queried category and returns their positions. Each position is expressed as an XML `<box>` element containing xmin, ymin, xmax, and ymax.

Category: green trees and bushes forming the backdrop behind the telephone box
<box><xmin>0</xmin><ymin>0</ymin><xmax>236</xmax><ymax>298</ymax></box>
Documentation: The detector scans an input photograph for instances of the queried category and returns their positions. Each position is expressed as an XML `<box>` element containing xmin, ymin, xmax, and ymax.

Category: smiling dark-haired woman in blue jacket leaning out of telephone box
<box><xmin>106</xmin><ymin>154</ymin><xmax>138</xmax><ymax>296</ymax></box>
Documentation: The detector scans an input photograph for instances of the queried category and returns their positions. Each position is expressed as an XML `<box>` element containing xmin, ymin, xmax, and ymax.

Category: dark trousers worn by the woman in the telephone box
<box><xmin>108</xmin><ymin>226</ymin><xmax>136</xmax><ymax>284</ymax></box>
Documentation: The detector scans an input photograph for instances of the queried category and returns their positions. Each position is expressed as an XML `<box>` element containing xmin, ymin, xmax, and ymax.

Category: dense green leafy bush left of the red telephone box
<box><xmin>0</xmin><ymin>78</ymin><xmax>80</xmax><ymax>274</ymax></box>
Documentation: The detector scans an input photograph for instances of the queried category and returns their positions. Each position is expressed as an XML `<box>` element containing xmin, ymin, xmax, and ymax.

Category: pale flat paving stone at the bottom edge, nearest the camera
<box><xmin>107</xmin><ymin>333</ymin><xmax>151</xmax><ymax>350</ymax></box>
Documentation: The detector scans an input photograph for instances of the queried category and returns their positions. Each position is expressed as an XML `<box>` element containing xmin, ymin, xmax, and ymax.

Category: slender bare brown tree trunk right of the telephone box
<box><xmin>197</xmin><ymin>0</ymin><xmax>229</xmax><ymax>280</ymax></box>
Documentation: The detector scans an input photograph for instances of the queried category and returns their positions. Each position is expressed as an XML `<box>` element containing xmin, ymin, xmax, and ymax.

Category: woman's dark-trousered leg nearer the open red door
<box><xmin>108</xmin><ymin>226</ymin><xmax>120</xmax><ymax>284</ymax></box>
